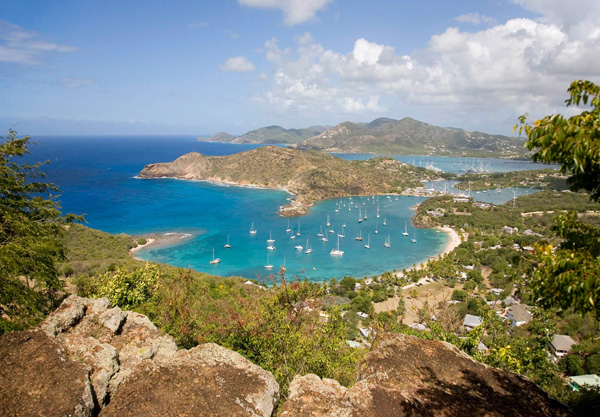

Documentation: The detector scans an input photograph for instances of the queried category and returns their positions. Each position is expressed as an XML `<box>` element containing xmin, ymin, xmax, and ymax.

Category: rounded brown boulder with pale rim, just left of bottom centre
<box><xmin>100</xmin><ymin>343</ymin><xmax>279</xmax><ymax>417</ymax></box>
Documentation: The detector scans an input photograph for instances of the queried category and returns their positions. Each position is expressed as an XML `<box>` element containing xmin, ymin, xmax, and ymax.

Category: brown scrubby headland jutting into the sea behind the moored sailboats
<box><xmin>139</xmin><ymin>146</ymin><xmax>438</xmax><ymax>216</ymax></box>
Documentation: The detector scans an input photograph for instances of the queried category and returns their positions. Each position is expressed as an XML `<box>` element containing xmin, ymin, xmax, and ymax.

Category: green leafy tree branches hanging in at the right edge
<box><xmin>515</xmin><ymin>80</ymin><xmax>600</xmax><ymax>316</ymax></box>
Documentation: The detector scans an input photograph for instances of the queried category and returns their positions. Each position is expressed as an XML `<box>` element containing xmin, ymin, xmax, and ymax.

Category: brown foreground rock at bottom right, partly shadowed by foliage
<box><xmin>279</xmin><ymin>334</ymin><xmax>569</xmax><ymax>417</ymax></box>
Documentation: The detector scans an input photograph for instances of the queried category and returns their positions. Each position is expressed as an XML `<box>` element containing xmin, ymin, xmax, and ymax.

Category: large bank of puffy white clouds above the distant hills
<box><xmin>253</xmin><ymin>0</ymin><xmax>600</xmax><ymax>130</ymax></box>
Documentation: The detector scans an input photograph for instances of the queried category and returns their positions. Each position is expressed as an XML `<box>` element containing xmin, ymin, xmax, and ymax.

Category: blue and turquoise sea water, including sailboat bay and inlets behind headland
<box><xmin>25</xmin><ymin>136</ymin><xmax>547</xmax><ymax>281</ymax></box>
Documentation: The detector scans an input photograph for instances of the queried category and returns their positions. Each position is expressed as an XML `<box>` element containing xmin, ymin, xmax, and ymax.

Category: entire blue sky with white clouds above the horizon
<box><xmin>0</xmin><ymin>0</ymin><xmax>600</xmax><ymax>136</ymax></box>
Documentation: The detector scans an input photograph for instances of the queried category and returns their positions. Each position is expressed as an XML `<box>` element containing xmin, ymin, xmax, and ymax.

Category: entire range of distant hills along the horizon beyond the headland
<box><xmin>198</xmin><ymin>117</ymin><xmax>530</xmax><ymax>159</ymax></box>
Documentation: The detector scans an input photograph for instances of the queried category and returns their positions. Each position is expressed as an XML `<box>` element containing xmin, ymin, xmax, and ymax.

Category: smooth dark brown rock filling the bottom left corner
<box><xmin>0</xmin><ymin>328</ymin><xmax>94</xmax><ymax>417</ymax></box>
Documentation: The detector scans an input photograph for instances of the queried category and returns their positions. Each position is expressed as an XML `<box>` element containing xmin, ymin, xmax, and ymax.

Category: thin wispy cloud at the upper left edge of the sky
<box><xmin>0</xmin><ymin>19</ymin><xmax>75</xmax><ymax>65</ymax></box>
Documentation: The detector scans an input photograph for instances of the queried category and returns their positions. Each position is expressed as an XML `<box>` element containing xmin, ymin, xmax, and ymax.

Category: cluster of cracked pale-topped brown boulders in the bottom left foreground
<box><xmin>0</xmin><ymin>296</ymin><xmax>279</xmax><ymax>416</ymax></box>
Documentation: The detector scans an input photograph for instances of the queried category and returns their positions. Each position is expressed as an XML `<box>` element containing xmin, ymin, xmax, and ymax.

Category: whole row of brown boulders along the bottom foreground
<box><xmin>0</xmin><ymin>296</ymin><xmax>568</xmax><ymax>417</ymax></box>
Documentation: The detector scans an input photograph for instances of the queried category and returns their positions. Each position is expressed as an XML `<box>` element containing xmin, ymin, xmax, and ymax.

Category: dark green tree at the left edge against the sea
<box><xmin>0</xmin><ymin>130</ymin><xmax>81</xmax><ymax>334</ymax></box>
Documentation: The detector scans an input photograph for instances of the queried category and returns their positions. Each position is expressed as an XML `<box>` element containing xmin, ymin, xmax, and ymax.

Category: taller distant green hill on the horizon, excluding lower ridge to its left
<box><xmin>298</xmin><ymin>117</ymin><xmax>526</xmax><ymax>158</ymax></box>
